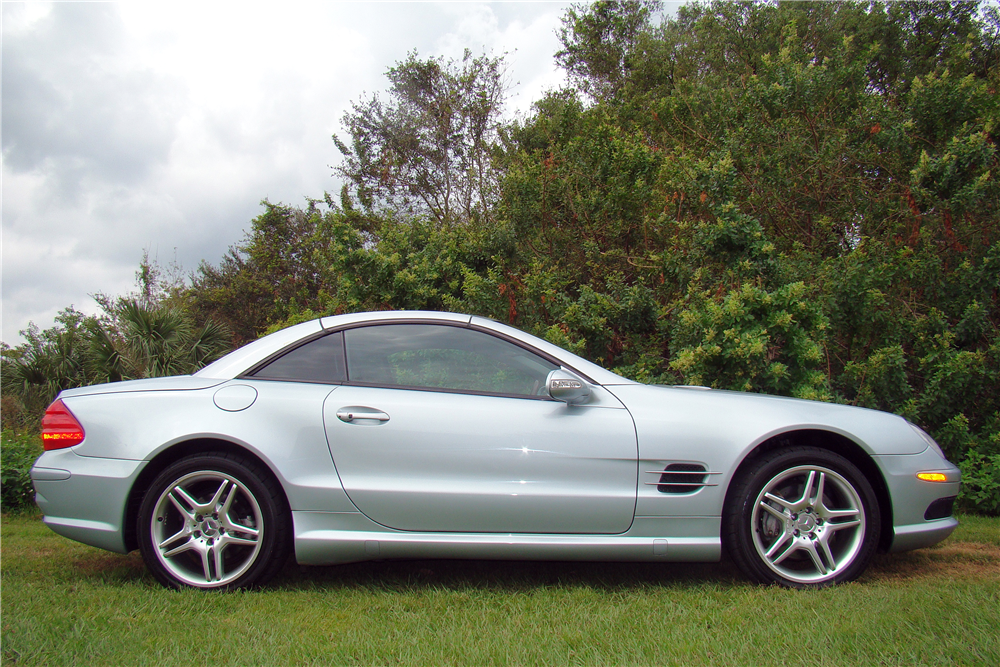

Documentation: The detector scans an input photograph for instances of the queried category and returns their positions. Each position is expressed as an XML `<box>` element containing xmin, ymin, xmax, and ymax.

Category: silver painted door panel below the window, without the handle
<box><xmin>324</xmin><ymin>386</ymin><xmax>636</xmax><ymax>534</ymax></box>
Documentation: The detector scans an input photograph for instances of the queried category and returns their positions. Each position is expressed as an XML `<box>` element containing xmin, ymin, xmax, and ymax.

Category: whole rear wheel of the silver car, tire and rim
<box><xmin>137</xmin><ymin>452</ymin><xmax>291</xmax><ymax>590</ymax></box>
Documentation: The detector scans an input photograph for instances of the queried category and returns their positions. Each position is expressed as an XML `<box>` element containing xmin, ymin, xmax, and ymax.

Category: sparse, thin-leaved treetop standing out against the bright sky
<box><xmin>333</xmin><ymin>51</ymin><xmax>507</xmax><ymax>226</ymax></box>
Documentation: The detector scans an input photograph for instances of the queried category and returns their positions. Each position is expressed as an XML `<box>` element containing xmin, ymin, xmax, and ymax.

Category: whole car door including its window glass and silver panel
<box><xmin>324</xmin><ymin>323</ymin><xmax>638</xmax><ymax>534</ymax></box>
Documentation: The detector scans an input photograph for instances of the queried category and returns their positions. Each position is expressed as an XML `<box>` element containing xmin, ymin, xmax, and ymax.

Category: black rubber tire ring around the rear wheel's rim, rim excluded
<box><xmin>137</xmin><ymin>453</ymin><xmax>288</xmax><ymax>591</ymax></box>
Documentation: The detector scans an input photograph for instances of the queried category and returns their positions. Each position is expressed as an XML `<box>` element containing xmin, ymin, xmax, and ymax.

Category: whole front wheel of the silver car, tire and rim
<box><xmin>722</xmin><ymin>447</ymin><xmax>881</xmax><ymax>588</ymax></box>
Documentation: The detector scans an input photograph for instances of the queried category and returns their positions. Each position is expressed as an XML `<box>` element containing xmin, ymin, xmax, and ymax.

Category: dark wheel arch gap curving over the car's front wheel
<box><xmin>722</xmin><ymin>428</ymin><xmax>892</xmax><ymax>552</ymax></box>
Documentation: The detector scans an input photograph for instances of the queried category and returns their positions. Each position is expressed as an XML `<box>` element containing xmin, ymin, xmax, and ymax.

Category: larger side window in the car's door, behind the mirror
<box><xmin>344</xmin><ymin>324</ymin><xmax>558</xmax><ymax>396</ymax></box>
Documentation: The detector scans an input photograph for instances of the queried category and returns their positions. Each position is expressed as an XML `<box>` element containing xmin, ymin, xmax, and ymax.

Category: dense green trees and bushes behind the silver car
<box><xmin>4</xmin><ymin>1</ymin><xmax>1000</xmax><ymax>512</ymax></box>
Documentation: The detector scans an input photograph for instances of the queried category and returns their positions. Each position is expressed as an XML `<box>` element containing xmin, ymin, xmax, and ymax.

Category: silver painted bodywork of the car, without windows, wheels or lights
<box><xmin>32</xmin><ymin>312</ymin><xmax>959</xmax><ymax>580</ymax></box>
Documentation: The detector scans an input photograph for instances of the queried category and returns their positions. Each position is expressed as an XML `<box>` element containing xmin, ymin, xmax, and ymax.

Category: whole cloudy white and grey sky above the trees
<box><xmin>2</xmin><ymin>2</ymin><xmax>566</xmax><ymax>344</ymax></box>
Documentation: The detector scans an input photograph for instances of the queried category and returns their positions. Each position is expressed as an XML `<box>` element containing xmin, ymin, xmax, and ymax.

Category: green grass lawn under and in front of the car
<box><xmin>0</xmin><ymin>515</ymin><xmax>1000</xmax><ymax>666</ymax></box>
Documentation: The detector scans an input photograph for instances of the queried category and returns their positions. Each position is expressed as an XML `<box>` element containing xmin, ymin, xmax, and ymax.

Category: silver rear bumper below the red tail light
<box><xmin>31</xmin><ymin>448</ymin><xmax>146</xmax><ymax>553</ymax></box>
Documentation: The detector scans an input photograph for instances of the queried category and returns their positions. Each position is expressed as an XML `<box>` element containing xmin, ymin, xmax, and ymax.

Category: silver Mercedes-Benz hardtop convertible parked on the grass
<box><xmin>31</xmin><ymin>312</ymin><xmax>960</xmax><ymax>589</ymax></box>
